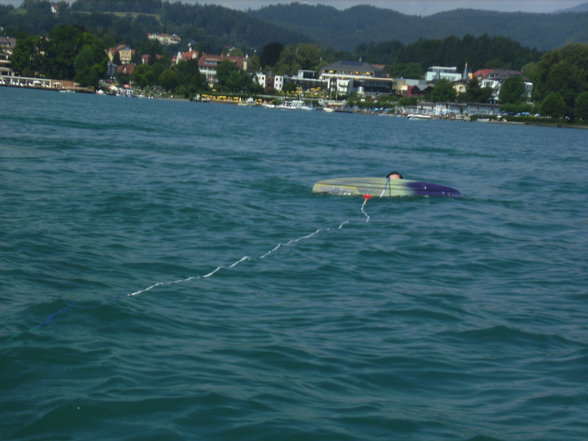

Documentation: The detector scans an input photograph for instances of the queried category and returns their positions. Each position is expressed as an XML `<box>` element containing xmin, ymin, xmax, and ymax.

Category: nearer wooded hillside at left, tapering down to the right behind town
<box><xmin>0</xmin><ymin>0</ymin><xmax>313</xmax><ymax>52</ymax></box>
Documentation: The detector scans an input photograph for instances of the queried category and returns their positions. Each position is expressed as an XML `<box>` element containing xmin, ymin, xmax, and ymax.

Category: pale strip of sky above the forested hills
<box><xmin>183</xmin><ymin>0</ymin><xmax>588</xmax><ymax>15</ymax></box>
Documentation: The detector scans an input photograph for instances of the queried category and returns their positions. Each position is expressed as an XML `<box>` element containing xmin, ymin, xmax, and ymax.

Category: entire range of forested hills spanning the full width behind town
<box><xmin>0</xmin><ymin>0</ymin><xmax>588</xmax><ymax>51</ymax></box>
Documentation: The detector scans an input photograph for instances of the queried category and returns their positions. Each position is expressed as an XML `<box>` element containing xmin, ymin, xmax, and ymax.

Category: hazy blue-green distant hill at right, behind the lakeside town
<box><xmin>249</xmin><ymin>3</ymin><xmax>588</xmax><ymax>50</ymax></box>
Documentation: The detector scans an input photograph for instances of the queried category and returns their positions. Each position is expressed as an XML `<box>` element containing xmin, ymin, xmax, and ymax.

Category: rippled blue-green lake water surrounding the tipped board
<box><xmin>0</xmin><ymin>88</ymin><xmax>588</xmax><ymax>441</ymax></box>
